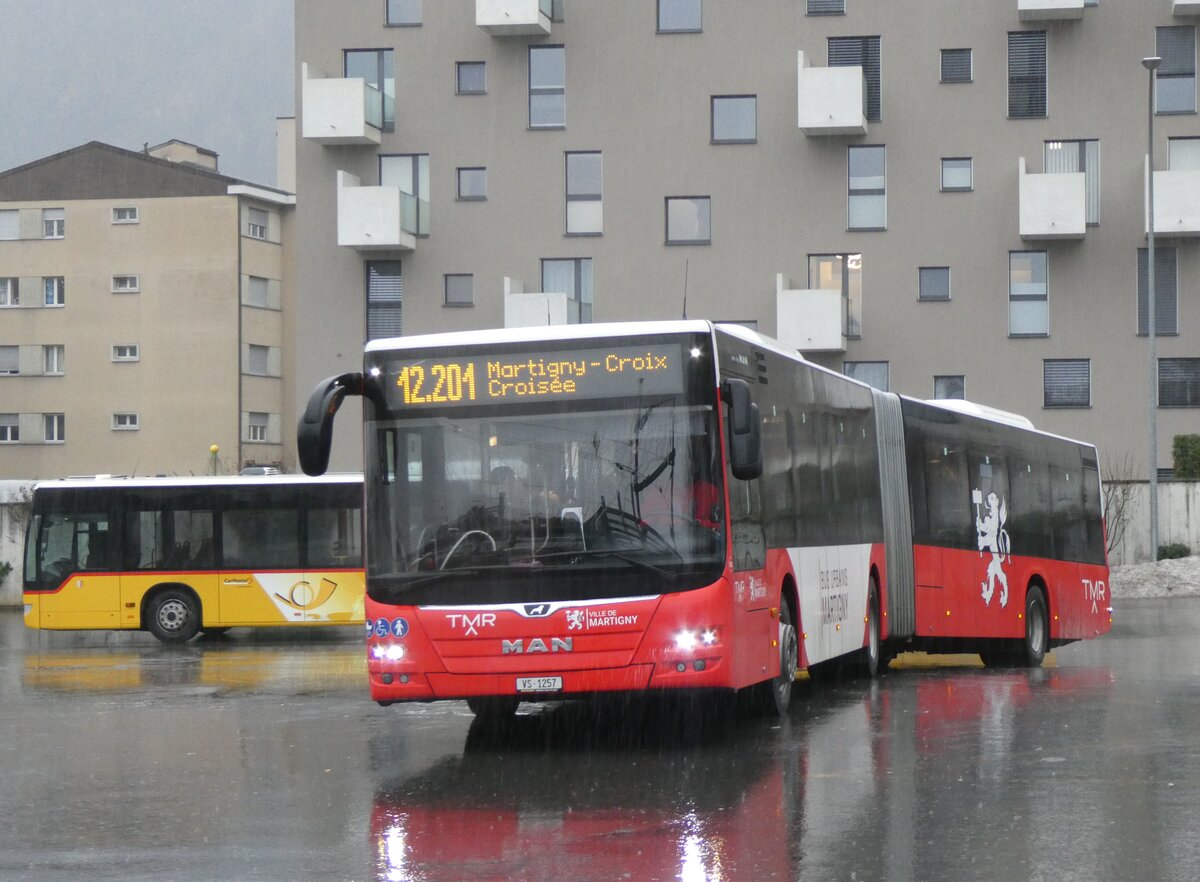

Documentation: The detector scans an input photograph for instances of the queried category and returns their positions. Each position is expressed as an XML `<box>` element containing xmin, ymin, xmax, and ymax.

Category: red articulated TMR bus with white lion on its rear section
<box><xmin>299</xmin><ymin>320</ymin><xmax>1110</xmax><ymax>713</ymax></box>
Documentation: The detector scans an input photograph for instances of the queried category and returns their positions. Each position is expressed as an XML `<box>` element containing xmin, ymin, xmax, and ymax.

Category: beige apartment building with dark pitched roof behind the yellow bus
<box><xmin>0</xmin><ymin>142</ymin><xmax>295</xmax><ymax>479</ymax></box>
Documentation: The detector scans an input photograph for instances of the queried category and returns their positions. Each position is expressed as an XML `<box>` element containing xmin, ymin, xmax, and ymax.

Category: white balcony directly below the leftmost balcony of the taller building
<box><xmin>337</xmin><ymin>172</ymin><xmax>430</xmax><ymax>251</ymax></box>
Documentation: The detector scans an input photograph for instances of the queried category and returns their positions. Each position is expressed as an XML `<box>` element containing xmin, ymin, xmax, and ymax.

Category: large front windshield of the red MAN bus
<box><xmin>367</xmin><ymin>395</ymin><xmax>725</xmax><ymax>604</ymax></box>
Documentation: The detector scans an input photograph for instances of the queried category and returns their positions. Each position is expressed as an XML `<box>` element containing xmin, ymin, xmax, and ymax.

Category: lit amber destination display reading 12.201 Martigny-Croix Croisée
<box><xmin>388</xmin><ymin>344</ymin><xmax>683</xmax><ymax>407</ymax></box>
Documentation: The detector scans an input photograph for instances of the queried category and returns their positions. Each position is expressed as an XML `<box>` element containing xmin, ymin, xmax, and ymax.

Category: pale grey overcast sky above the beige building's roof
<box><xmin>0</xmin><ymin>0</ymin><xmax>295</xmax><ymax>186</ymax></box>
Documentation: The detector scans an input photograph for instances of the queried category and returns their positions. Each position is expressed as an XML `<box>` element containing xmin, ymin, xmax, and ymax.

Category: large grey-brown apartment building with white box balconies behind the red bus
<box><xmin>294</xmin><ymin>0</ymin><xmax>1200</xmax><ymax>478</ymax></box>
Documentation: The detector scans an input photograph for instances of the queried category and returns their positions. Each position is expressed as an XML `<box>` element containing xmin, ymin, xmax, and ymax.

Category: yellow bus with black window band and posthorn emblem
<box><xmin>24</xmin><ymin>475</ymin><xmax>364</xmax><ymax>643</ymax></box>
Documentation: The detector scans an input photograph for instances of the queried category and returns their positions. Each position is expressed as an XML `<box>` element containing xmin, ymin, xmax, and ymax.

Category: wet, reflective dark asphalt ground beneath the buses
<box><xmin>0</xmin><ymin>599</ymin><xmax>1200</xmax><ymax>882</ymax></box>
